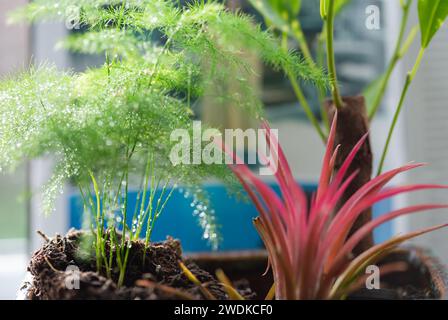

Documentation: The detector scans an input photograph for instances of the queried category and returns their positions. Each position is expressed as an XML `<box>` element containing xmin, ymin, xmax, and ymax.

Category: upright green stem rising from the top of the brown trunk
<box><xmin>326</xmin><ymin>0</ymin><xmax>344</xmax><ymax>109</ymax></box>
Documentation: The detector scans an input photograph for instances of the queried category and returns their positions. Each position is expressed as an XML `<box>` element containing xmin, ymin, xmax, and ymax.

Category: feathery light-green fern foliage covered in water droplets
<box><xmin>0</xmin><ymin>0</ymin><xmax>327</xmax><ymax>250</ymax></box>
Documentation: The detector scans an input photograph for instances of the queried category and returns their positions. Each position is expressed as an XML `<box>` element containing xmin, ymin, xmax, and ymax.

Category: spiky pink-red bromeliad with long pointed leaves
<box><xmin>224</xmin><ymin>115</ymin><xmax>448</xmax><ymax>299</ymax></box>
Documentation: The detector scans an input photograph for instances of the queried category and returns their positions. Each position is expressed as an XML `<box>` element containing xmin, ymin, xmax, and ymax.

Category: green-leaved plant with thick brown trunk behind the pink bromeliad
<box><xmin>250</xmin><ymin>0</ymin><xmax>448</xmax><ymax>252</ymax></box>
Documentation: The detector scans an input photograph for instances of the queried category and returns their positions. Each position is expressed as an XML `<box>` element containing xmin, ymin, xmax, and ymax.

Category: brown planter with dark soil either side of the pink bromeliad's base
<box><xmin>191</xmin><ymin>247</ymin><xmax>448</xmax><ymax>300</ymax></box>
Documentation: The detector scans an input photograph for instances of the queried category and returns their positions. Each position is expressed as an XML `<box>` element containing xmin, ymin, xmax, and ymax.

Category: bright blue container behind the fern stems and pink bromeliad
<box><xmin>69</xmin><ymin>183</ymin><xmax>392</xmax><ymax>252</ymax></box>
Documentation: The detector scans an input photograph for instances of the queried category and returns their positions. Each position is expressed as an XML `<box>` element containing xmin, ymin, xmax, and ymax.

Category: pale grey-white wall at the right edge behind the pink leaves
<box><xmin>402</xmin><ymin>6</ymin><xmax>448</xmax><ymax>263</ymax></box>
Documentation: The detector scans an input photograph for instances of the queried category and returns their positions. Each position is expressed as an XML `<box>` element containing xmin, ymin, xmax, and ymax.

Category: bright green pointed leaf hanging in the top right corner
<box><xmin>418</xmin><ymin>0</ymin><xmax>448</xmax><ymax>48</ymax></box>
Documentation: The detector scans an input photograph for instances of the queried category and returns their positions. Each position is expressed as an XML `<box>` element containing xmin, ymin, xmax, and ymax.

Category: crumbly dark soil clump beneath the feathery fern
<box><xmin>28</xmin><ymin>231</ymin><xmax>252</xmax><ymax>300</ymax></box>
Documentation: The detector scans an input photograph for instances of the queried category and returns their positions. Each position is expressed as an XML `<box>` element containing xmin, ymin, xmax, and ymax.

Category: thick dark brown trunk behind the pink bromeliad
<box><xmin>325</xmin><ymin>96</ymin><xmax>373</xmax><ymax>255</ymax></box>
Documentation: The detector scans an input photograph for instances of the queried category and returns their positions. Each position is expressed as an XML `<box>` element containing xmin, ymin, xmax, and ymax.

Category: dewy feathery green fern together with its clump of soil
<box><xmin>0</xmin><ymin>0</ymin><xmax>325</xmax><ymax>299</ymax></box>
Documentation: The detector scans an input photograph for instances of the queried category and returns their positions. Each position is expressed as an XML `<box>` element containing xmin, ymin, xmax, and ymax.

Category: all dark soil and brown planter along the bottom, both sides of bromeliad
<box><xmin>23</xmin><ymin>231</ymin><xmax>448</xmax><ymax>300</ymax></box>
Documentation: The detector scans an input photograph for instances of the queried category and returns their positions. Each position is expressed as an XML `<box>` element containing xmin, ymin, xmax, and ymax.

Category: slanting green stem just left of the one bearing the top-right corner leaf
<box><xmin>369</xmin><ymin>0</ymin><xmax>413</xmax><ymax>120</ymax></box>
